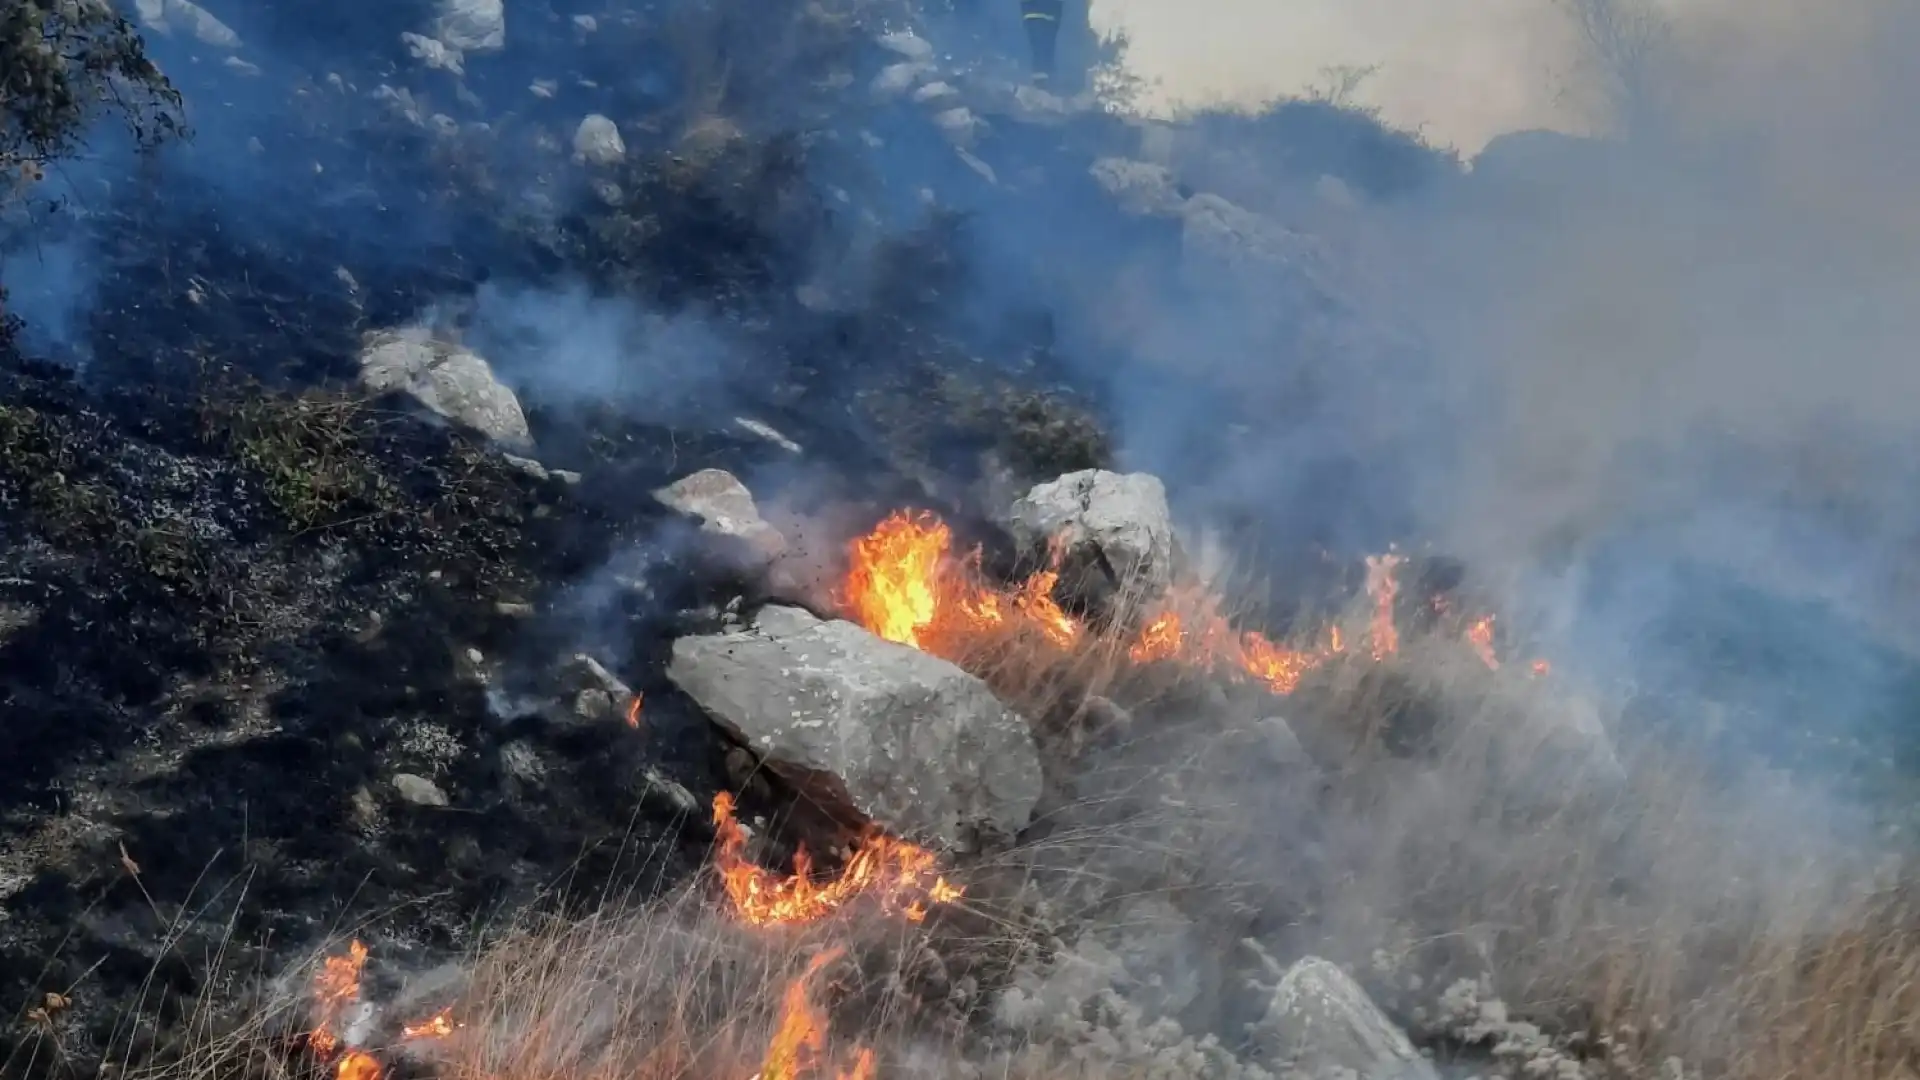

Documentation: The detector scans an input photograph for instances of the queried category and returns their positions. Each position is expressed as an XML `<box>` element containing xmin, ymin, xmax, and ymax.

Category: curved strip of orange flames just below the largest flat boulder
<box><xmin>714</xmin><ymin>792</ymin><xmax>964</xmax><ymax>926</ymax></box>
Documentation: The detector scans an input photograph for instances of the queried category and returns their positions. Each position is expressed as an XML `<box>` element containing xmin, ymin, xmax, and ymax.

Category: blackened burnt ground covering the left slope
<box><xmin>0</xmin><ymin>39</ymin><xmax>1108</xmax><ymax>1076</ymax></box>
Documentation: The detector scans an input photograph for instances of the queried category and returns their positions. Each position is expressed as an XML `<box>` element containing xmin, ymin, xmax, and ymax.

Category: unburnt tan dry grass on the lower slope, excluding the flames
<box><xmin>101</xmin><ymin>553</ymin><xmax>1920</xmax><ymax>1080</ymax></box>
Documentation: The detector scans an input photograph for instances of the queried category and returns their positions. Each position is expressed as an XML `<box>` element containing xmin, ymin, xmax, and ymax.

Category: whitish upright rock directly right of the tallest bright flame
<box><xmin>1008</xmin><ymin>469</ymin><xmax>1173</xmax><ymax>603</ymax></box>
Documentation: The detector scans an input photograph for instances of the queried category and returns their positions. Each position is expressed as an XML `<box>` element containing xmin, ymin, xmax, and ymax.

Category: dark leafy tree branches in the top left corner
<box><xmin>0</xmin><ymin>0</ymin><xmax>184</xmax><ymax>190</ymax></box>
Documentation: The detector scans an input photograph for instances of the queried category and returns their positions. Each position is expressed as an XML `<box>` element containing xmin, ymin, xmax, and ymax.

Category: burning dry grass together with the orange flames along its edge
<box><xmin>41</xmin><ymin>515</ymin><xmax>1920</xmax><ymax>1080</ymax></box>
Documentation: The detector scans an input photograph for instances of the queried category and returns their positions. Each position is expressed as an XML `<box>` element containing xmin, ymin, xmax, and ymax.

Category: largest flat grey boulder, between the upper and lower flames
<box><xmin>666</xmin><ymin>607</ymin><xmax>1041</xmax><ymax>849</ymax></box>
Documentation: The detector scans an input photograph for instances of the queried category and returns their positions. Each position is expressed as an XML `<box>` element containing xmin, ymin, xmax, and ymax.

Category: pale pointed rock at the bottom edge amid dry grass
<box><xmin>1252</xmin><ymin>957</ymin><xmax>1438</xmax><ymax>1080</ymax></box>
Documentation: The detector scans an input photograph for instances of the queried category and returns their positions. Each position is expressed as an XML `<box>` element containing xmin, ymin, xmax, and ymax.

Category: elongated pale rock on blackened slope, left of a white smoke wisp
<box><xmin>359</xmin><ymin>331</ymin><xmax>534</xmax><ymax>450</ymax></box>
